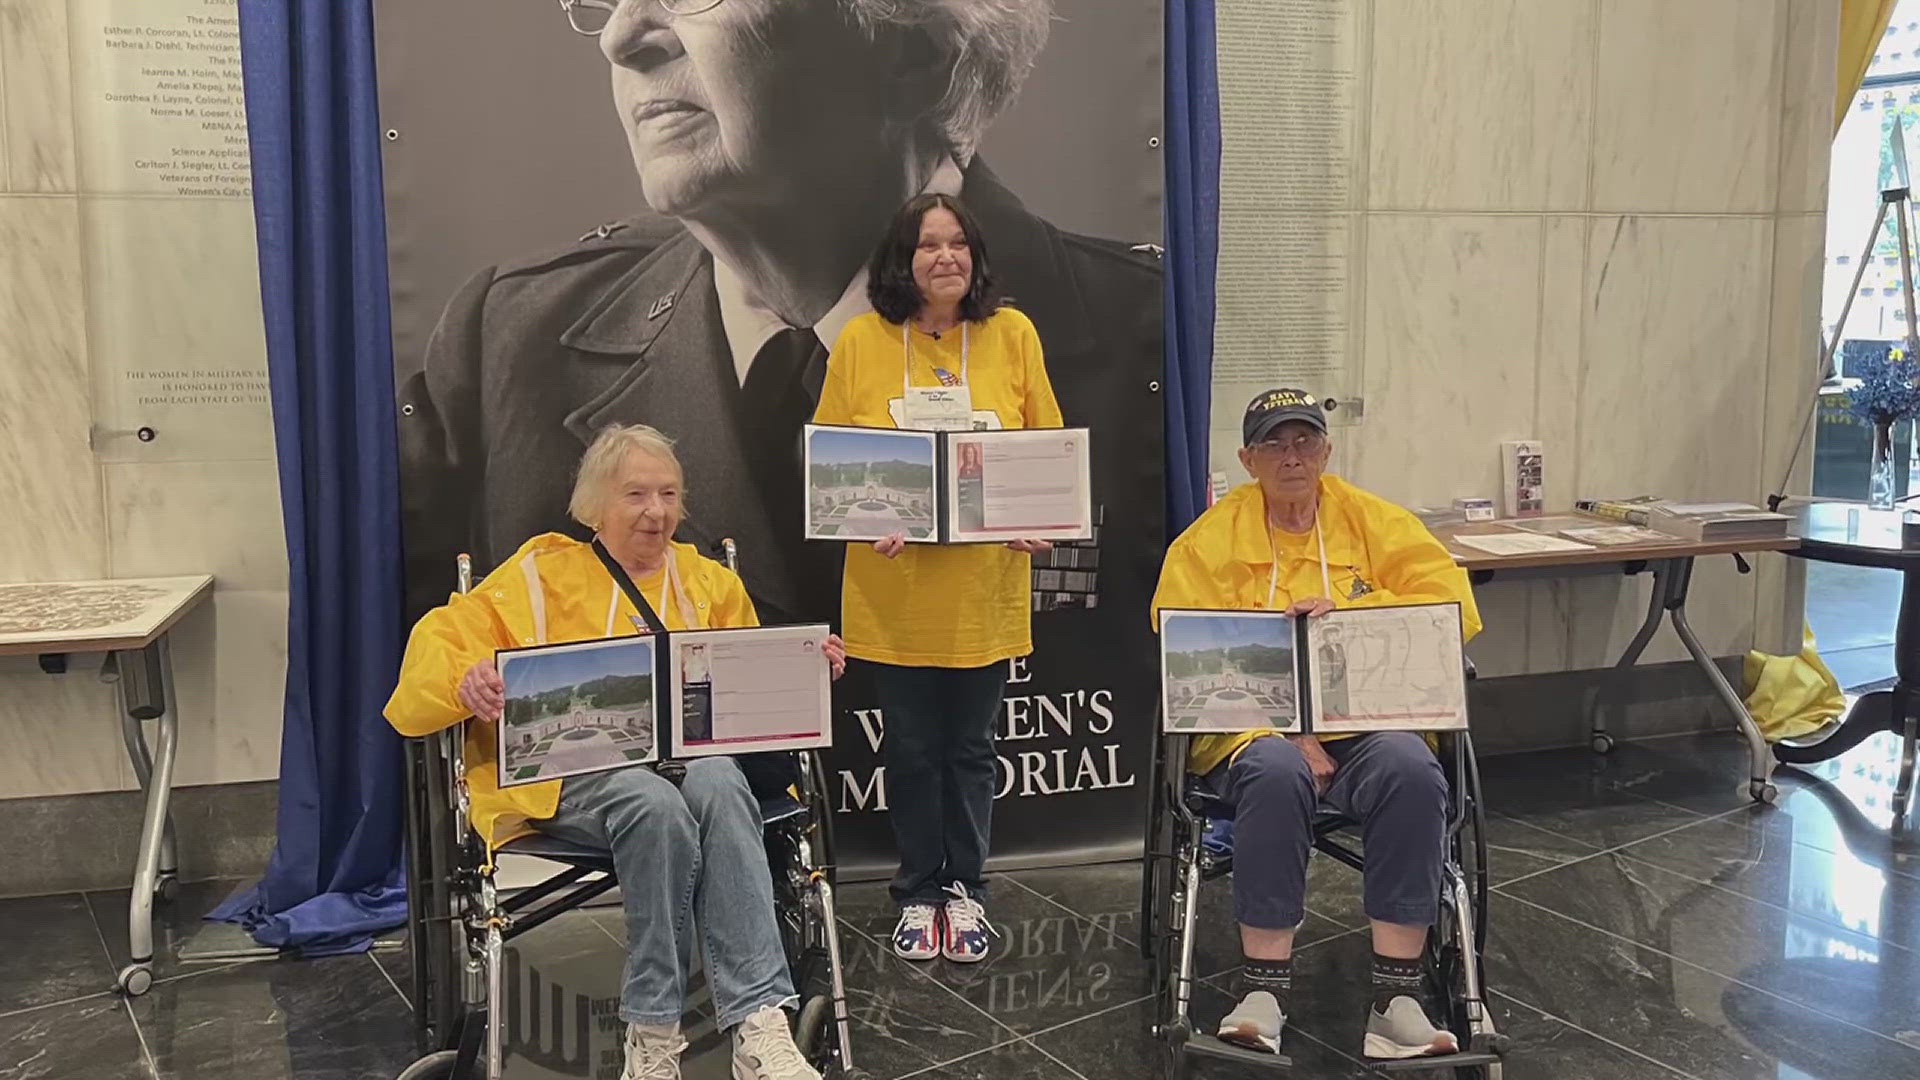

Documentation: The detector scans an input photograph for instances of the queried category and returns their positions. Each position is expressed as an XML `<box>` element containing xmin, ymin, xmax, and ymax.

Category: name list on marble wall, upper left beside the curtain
<box><xmin>71</xmin><ymin>0</ymin><xmax>253</xmax><ymax>198</ymax></box>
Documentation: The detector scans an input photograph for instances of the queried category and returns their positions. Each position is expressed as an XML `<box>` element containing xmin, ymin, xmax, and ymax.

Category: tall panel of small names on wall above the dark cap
<box><xmin>1212</xmin><ymin>0</ymin><xmax>1359</xmax><ymax>469</ymax></box>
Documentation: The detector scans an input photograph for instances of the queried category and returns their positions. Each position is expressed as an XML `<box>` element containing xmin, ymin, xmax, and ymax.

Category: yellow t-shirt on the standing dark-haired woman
<box><xmin>814</xmin><ymin>307</ymin><xmax>1064</xmax><ymax>667</ymax></box>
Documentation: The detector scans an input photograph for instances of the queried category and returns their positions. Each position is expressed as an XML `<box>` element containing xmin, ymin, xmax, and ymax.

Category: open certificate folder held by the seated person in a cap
<box><xmin>1160</xmin><ymin>603</ymin><xmax>1467</xmax><ymax>734</ymax></box>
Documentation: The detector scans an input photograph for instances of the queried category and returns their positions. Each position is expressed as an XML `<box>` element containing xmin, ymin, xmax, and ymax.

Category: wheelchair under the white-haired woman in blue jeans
<box><xmin>399</xmin><ymin>540</ymin><xmax>866</xmax><ymax>1080</ymax></box>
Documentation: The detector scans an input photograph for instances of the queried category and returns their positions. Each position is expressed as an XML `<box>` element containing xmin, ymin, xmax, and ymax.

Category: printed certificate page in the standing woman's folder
<box><xmin>947</xmin><ymin>429</ymin><xmax>1092</xmax><ymax>544</ymax></box>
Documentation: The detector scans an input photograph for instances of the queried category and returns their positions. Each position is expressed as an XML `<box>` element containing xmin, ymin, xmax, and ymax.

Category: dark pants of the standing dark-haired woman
<box><xmin>870</xmin><ymin>663</ymin><xmax>1006</xmax><ymax>903</ymax></box>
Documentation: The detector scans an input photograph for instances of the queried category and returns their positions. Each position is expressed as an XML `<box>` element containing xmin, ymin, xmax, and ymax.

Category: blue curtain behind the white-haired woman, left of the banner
<box><xmin>211</xmin><ymin>0</ymin><xmax>407</xmax><ymax>955</ymax></box>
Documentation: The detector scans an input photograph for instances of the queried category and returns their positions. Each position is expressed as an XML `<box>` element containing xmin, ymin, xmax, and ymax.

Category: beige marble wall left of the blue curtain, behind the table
<box><xmin>0</xmin><ymin>0</ymin><xmax>286</xmax><ymax>798</ymax></box>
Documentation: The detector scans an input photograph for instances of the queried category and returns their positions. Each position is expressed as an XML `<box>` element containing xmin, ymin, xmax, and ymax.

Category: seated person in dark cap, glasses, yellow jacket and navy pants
<box><xmin>1154</xmin><ymin>390</ymin><xmax>1480</xmax><ymax>1059</ymax></box>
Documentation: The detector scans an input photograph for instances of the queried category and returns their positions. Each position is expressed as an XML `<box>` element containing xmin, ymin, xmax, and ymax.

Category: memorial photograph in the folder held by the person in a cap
<box><xmin>1160</xmin><ymin>611</ymin><xmax>1300</xmax><ymax>732</ymax></box>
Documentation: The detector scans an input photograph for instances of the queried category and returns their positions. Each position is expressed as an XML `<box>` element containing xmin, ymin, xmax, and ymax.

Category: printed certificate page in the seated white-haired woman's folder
<box><xmin>666</xmin><ymin>625</ymin><xmax>833</xmax><ymax>757</ymax></box>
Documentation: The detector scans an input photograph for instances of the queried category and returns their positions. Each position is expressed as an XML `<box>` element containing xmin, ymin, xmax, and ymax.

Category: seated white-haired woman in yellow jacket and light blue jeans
<box><xmin>386</xmin><ymin>425</ymin><xmax>845</xmax><ymax>1080</ymax></box>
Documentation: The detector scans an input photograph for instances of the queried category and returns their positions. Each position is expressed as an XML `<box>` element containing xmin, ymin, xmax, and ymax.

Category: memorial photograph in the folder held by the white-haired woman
<box><xmin>499</xmin><ymin>638</ymin><xmax>657</xmax><ymax>788</ymax></box>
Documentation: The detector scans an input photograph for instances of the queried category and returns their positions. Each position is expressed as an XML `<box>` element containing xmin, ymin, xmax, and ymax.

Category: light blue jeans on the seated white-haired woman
<box><xmin>534</xmin><ymin>757</ymin><xmax>795</xmax><ymax>1030</ymax></box>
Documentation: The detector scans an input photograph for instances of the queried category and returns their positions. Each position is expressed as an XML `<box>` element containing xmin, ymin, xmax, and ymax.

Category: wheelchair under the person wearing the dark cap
<box><xmin>1140</xmin><ymin>669</ymin><xmax>1509</xmax><ymax>1080</ymax></box>
